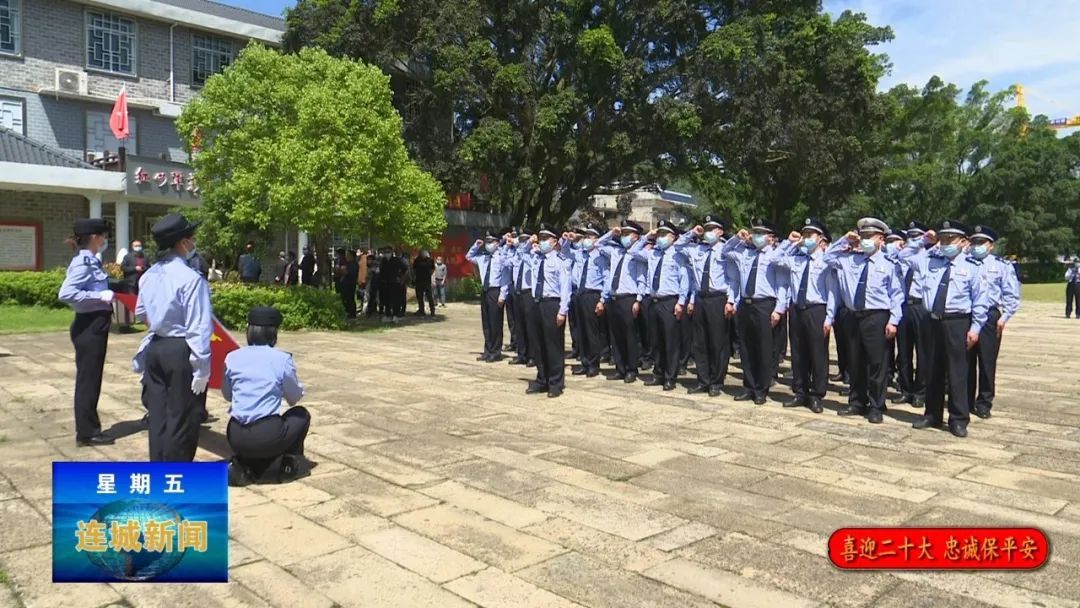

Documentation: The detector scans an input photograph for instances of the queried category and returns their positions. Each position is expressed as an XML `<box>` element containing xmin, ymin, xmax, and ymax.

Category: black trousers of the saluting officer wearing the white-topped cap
<box><xmin>847</xmin><ymin>310</ymin><xmax>889</xmax><ymax>411</ymax></box>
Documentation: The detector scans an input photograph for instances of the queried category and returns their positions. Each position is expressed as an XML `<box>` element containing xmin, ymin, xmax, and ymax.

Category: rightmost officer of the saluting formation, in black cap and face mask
<box><xmin>968</xmin><ymin>225</ymin><xmax>1020</xmax><ymax>418</ymax></box>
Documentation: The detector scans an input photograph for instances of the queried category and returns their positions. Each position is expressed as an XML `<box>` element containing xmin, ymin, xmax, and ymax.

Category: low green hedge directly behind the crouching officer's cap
<box><xmin>211</xmin><ymin>282</ymin><xmax>345</xmax><ymax>330</ymax></box>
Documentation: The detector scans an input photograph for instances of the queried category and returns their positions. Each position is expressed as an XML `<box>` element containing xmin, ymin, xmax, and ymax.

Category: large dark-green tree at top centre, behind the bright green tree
<box><xmin>285</xmin><ymin>0</ymin><xmax>731</xmax><ymax>224</ymax></box>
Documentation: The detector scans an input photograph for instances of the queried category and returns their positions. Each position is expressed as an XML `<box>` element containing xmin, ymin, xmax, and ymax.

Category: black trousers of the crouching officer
<box><xmin>225</xmin><ymin>405</ymin><xmax>311</xmax><ymax>478</ymax></box>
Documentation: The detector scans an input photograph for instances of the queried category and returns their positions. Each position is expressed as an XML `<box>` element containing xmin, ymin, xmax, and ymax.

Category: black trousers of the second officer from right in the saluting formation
<box><xmin>927</xmin><ymin>313</ymin><xmax>971</xmax><ymax>422</ymax></box>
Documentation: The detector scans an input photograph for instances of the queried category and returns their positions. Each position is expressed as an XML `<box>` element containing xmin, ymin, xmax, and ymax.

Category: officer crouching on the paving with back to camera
<box><xmin>221</xmin><ymin>307</ymin><xmax>311</xmax><ymax>486</ymax></box>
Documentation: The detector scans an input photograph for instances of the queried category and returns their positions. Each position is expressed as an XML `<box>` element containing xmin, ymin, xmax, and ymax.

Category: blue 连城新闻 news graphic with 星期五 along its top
<box><xmin>53</xmin><ymin>462</ymin><xmax>229</xmax><ymax>583</ymax></box>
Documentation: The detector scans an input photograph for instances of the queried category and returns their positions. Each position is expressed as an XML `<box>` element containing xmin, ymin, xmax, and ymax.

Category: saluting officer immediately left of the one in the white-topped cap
<box><xmin>781</xmin><ymin>217</ymin><xmax>837</xmax><ymax>414</ymax></box>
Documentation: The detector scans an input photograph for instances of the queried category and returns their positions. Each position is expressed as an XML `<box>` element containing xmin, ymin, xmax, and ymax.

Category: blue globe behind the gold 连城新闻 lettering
<box><xmin>85</xmin><ymin>500</ymin><xmax>187</xmax><ymax>581</ymax></box>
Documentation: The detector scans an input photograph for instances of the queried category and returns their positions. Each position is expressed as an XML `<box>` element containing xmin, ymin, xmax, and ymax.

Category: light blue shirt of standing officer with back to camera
<box><xmin>133</xmin><ymin>253</ymin><xmax>214</xmax><ymax>379</ymax></box>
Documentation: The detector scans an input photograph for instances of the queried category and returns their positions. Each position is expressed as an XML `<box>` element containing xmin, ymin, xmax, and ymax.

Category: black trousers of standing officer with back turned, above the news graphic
<box><xmin>143</xmin><ymin>337</ymin><xmax>200</xmax><ymax>462</ymax></box>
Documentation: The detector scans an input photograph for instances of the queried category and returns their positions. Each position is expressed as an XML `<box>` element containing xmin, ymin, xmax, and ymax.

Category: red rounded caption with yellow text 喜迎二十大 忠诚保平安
<box><xmin>828</xmin><ymin>528</ymin><xmax>1050</xmax><ymax>570</ymax></box>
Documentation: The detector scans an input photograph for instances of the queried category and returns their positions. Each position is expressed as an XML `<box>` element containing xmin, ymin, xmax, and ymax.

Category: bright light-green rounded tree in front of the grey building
<box><xmin>176</xmin><ymin>44</ymin><xmax>446</xmax><ymax>274</ymax></box>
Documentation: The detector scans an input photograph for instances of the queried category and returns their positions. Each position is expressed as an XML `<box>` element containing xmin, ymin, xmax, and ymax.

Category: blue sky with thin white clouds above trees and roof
<box><xmin>221</xmin><ymin>0</ymin><xmax>1080</xmax><ymax>122</ymax></box>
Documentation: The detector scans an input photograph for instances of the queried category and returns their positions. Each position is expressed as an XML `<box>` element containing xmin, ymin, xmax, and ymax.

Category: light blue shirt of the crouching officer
<box><xmin>221</xmin><ymin>346</ymin><xmax>303</xmax><ymax>424</ymax></box>
